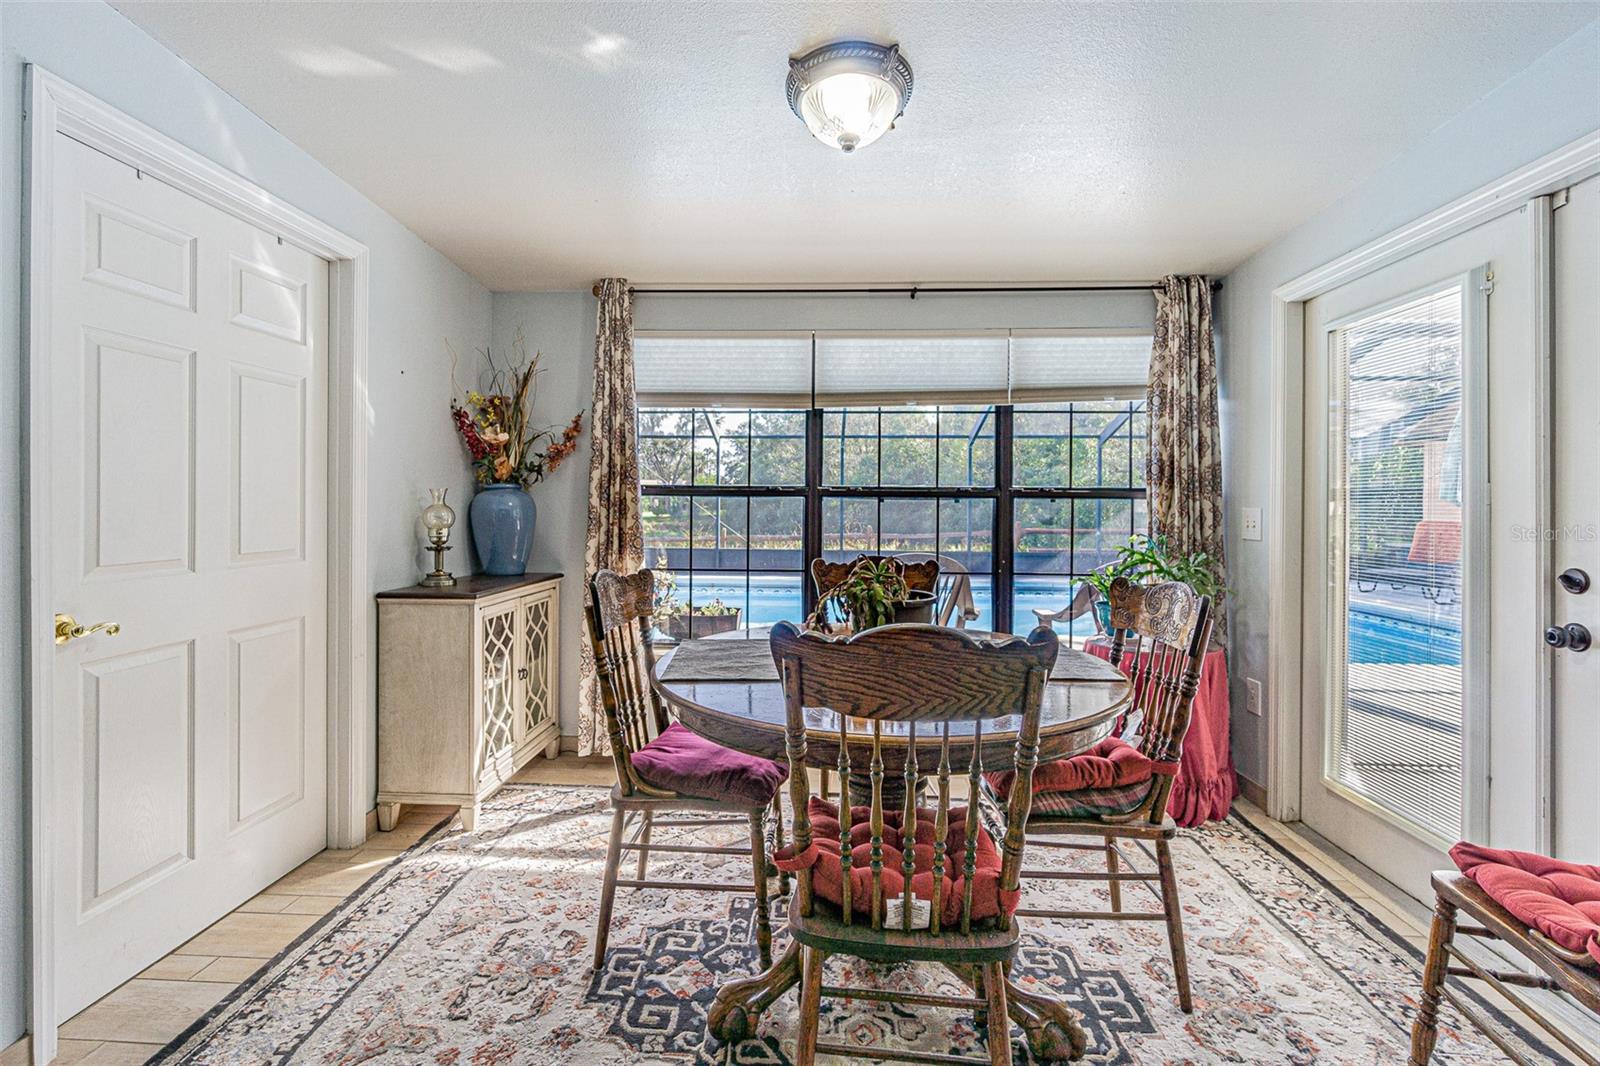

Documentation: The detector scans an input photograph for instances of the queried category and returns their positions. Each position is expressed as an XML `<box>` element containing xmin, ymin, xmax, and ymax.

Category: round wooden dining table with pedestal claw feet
<box><xmin>650</xmin><ymin>627</ymin><xmax>1131</xmax><ymax>1061</ymax></box>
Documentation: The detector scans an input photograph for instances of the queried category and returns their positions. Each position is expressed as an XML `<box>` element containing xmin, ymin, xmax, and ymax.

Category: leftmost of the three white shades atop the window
<box><xmin>634</xmin><ymin>333</ymin><xmax>811</xmax><ymax>408</ymax></box>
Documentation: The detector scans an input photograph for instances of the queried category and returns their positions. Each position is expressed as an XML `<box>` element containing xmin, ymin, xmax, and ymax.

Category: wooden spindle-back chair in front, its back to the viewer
<box><xmin>771</xmin><ymin>623</ymin><xmax>1058</xmax><ymax>1066</ymax></box>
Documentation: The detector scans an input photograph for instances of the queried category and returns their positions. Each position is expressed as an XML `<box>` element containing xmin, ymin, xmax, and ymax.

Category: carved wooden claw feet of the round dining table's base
<box><xmin>706</xmin><ymin>941</ymin><xmax>1088</xmax><ymax>1063</ymax></box>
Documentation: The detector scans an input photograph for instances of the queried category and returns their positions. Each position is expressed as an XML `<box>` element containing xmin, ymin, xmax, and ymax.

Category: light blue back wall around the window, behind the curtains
<box><xmin>494</xmin><ymin>291</ymin><xmax>1155</xmax><ymax>736</ymax></box>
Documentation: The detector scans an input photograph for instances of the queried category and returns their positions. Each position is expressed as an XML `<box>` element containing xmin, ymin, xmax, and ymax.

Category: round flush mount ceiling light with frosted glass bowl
<box><xmin>789</xmin><ymin>40</ymin><xmax>910</xmax><ymax>152</ymax></box>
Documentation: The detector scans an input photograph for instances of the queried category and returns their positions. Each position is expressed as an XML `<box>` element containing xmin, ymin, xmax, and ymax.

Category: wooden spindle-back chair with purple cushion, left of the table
<box><xmin>584</xmin><ymin>570</ymin><xmax>782</xmax><ymax>970</ymax></box>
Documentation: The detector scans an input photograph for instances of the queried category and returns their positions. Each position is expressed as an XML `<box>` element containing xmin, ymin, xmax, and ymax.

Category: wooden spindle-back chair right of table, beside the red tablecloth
<box><xmin>1018</xmin><ymin>578</ymin><xmax>1211</xmax><ymax>1013</ymax></box>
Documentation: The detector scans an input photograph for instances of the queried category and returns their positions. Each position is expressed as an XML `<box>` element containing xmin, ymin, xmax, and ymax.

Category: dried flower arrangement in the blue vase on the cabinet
<box><xmin>450</xmin><ymin>330</ymin><xmax>584</xmax><ymax>488</ymax></box>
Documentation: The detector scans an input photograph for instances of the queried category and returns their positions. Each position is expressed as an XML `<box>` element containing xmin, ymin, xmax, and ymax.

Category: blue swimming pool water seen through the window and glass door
<box><xmin>677</xmin><ymin>571</ymin><xmax>1461</xmax><ymax>666</ymax></box>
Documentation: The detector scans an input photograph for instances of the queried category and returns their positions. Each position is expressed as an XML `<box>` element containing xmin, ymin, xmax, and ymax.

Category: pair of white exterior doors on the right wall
<box><xmin>1301</xmin><ymin>181</ymin><xmax>1600</xmax><ymax>898</ymax></box>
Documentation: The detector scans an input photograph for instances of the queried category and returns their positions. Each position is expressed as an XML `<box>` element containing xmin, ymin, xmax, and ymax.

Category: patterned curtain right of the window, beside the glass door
<box><xmin>1146</xmin><ymin>274</ymin><xmax>1227</xmax><ymax>630</ymax></box>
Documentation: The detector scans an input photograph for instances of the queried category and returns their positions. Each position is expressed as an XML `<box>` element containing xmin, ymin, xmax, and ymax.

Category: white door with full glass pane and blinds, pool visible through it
<box><xmin>1301</xmin><ymin>206</ymin><xmax>1542</xmax><ymax>898</ymax></box>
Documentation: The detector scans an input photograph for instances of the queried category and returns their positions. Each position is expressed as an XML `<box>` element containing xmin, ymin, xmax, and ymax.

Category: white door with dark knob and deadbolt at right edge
<box><xmin>1541</xmin><ymin>178</ymin><xmax>1600</xmax><ymax>863</ymax></box>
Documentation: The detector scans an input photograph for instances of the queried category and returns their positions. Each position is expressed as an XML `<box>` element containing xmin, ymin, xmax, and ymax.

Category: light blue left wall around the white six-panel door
<box><xmin>0</xmin><ymin>3</ymin><xmax>490</xmax><ymax>1048</ymax></box>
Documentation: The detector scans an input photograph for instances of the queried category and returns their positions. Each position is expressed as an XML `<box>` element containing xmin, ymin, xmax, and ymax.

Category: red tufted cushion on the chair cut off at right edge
<box><xmin>1450</xmin><ymin>840</ymin><xmax>1600</xmax><ymax>962</ymax></box>
